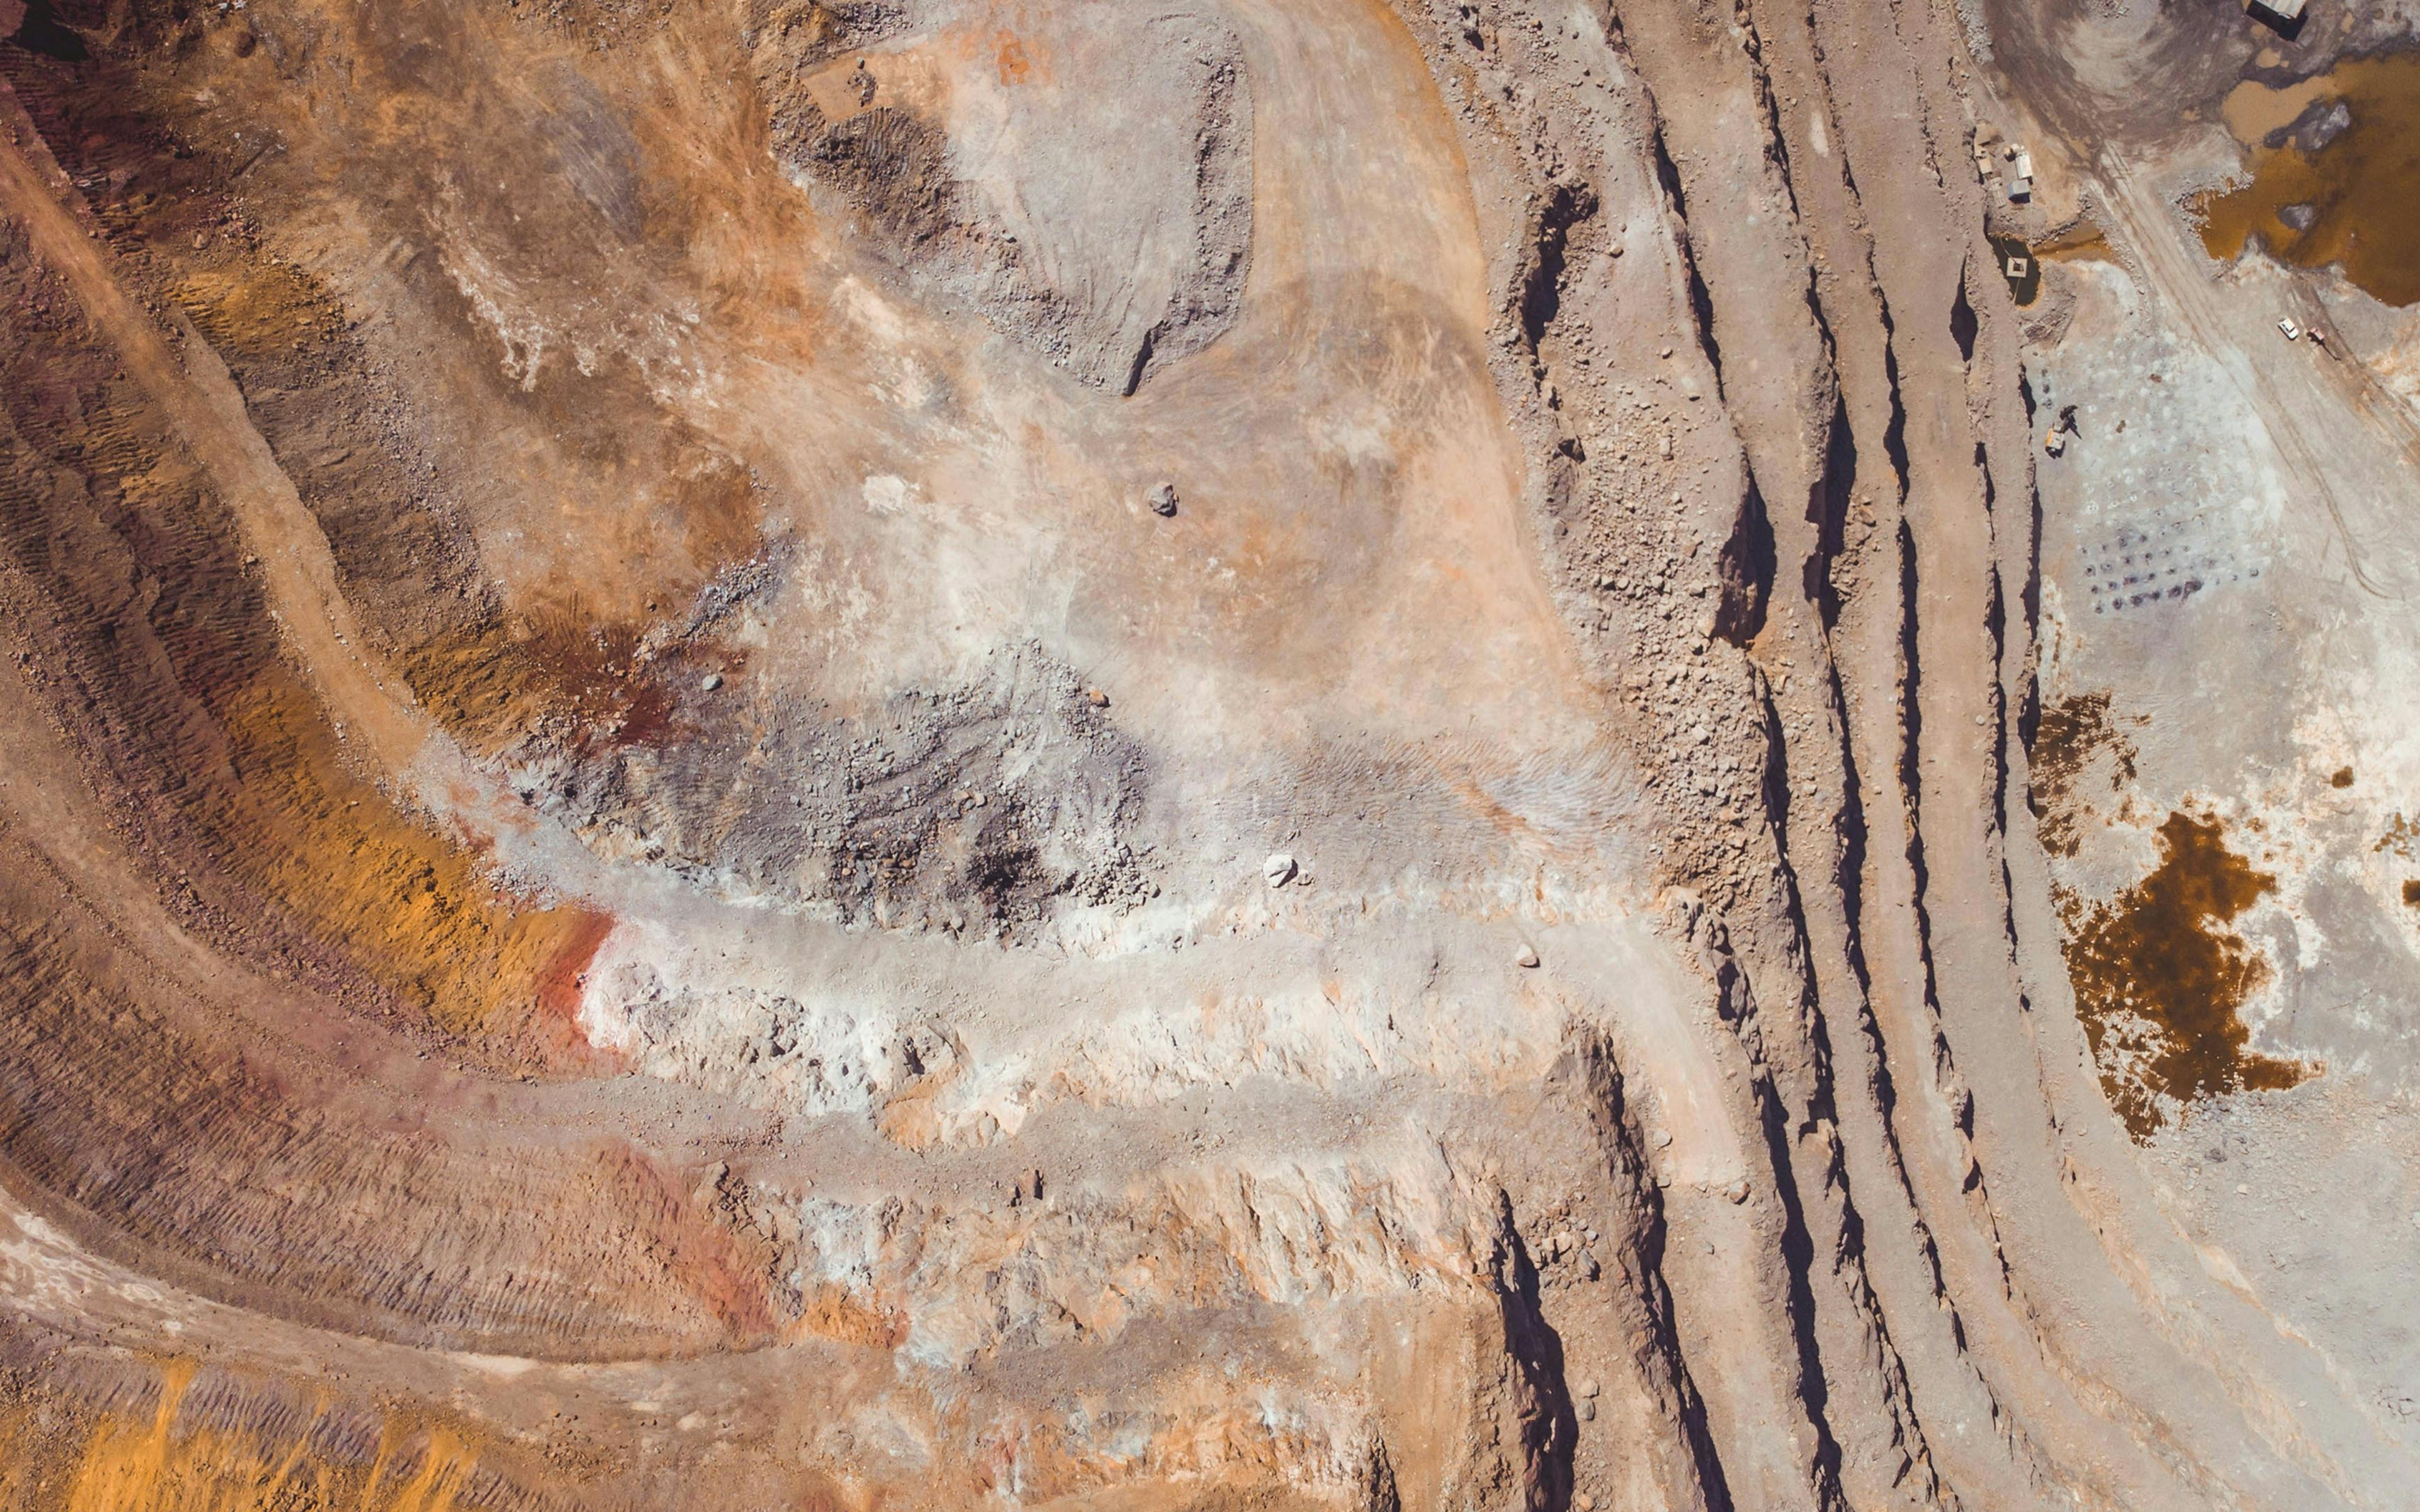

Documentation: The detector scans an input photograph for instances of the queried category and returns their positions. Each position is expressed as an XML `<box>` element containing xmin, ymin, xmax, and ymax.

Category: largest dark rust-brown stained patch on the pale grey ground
<box><xmin>2062</xmin><ymin>813</ymin><xmax>2308</xmax><ymax>1140</ymax></box>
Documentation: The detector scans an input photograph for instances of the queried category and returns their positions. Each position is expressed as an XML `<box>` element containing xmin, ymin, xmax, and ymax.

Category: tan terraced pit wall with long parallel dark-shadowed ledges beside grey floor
<box><xmin>1414</xmin><ymin>5</ymin><xmax>2361</xmax><ymax>1507</ymax></box>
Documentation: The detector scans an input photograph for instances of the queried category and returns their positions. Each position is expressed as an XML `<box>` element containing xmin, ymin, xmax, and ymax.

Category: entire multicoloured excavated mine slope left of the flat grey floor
<box><xmin>0</xmin><ymin>0</ymin><xmax>2415</xmax><ymax>1512</ymax></box>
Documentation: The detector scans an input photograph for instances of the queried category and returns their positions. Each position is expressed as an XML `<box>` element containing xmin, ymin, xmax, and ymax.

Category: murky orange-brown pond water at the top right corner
<box><xmin>2198</xmin><ymin>53</ymin><xmax>2420</xmax><ymax>305</ymax></box>
